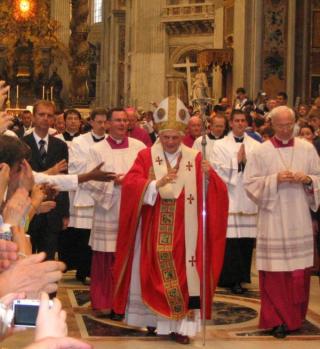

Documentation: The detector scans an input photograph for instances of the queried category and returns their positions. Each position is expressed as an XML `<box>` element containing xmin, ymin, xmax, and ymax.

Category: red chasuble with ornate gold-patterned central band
<box><xmin>113</xmin><ymin>148</ymin><xmax>228</xmax><ymax>319</ymax></box>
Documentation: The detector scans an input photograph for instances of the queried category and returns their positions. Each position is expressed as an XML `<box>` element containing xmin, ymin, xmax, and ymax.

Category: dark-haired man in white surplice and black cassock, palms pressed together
<box><xmin>209</xmin><ymin>110</ymin><xmax>260</xmax><ymax>294</ymax></box>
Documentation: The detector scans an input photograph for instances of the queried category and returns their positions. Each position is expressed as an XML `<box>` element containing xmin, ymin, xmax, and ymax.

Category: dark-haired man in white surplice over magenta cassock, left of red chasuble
<box><xmin>84</xmin><ymin>109</ymin><xmax>145</xmax><ymax>311</ymax></box>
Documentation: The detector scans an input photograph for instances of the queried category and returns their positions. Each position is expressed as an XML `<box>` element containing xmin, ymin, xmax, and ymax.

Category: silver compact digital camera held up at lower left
<box><xmin>13</xmin><ymin>299</ymin><xmax>53</xmax><ymax>327</ymax></box>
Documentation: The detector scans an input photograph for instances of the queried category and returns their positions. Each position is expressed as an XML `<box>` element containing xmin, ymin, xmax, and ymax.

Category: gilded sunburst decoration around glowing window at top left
<box><xmin>0</xmin><ymin>0</ymin><xmax>68</xmax><ymax>80</ymax></box>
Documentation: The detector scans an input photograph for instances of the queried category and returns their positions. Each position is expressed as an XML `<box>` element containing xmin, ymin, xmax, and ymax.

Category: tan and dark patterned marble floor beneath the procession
<box><xmin>0</xmin><ymin>272</ymin><xmax>320</xmax><ymax>349</ymax></box>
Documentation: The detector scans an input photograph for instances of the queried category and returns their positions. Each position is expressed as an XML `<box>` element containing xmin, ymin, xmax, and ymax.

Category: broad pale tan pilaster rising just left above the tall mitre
<box><xmin>125</xmin><ymin>0</ymin><xmax>166</xmax><ymax>109</ymax></box>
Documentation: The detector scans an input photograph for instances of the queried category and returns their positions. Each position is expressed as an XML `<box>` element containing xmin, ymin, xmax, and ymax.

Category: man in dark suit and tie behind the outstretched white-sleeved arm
<box><xmin>23</xmin><ymin>101</ymin><xmax>69</xmax><ymax>259</ymax></box>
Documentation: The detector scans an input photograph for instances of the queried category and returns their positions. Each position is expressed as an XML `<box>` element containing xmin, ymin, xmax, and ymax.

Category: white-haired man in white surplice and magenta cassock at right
<box><xmin>244</xmin><ymin>106</ymin><xmax>320</xmax><ymax>338</ymax></box>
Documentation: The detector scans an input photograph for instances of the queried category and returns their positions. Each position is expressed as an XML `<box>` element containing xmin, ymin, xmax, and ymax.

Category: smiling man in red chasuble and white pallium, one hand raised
<box><xmin>113</xmin><ymin>98</ymin><xmax>228</xmax><ymax>340</ymax></box>
